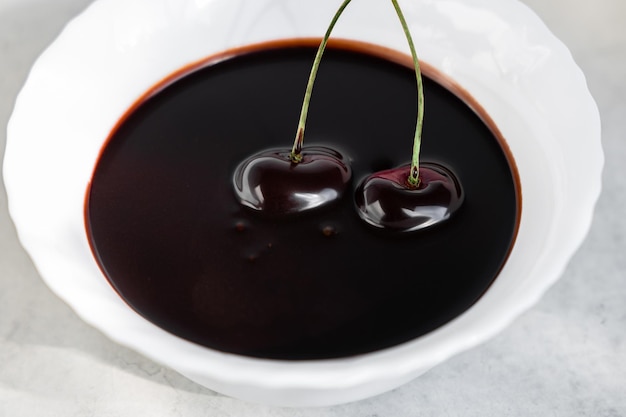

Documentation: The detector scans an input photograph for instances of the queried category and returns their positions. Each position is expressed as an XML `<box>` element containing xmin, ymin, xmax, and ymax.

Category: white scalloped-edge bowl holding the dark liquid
<box><xmin>4</xmin><ymin>0</ymin><xmax>603</xmax><ymax>406</ymax></box>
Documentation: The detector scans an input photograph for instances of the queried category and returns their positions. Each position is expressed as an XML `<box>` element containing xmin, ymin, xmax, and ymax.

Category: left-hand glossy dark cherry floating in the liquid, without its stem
<box><xmin>233</xmin><ymin>146</ymin><xmax>352</xmax><ymax>216</ymax></box>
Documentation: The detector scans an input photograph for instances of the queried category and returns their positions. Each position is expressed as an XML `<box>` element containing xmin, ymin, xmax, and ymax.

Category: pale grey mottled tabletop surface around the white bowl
<box><xmin>0</xmin><ymin>0</ymin><xmax>626</xmax><ymax>417</ymax></box>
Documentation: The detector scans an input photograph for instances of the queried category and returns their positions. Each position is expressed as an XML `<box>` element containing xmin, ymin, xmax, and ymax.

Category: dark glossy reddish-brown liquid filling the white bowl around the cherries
<box><xmin>86</xmin><ymin>39</ymin><xmax>519</xmax><ymax>359</ymax></box>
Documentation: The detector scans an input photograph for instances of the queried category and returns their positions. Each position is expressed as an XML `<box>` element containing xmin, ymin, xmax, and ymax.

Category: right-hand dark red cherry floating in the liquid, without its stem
<box><xmin>355</xmin><ymin>163</ymin><xmax>463</xmax><ymax>232</ymax></box>
